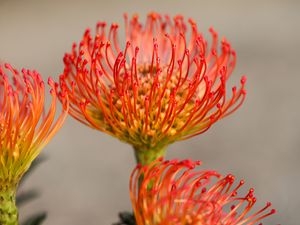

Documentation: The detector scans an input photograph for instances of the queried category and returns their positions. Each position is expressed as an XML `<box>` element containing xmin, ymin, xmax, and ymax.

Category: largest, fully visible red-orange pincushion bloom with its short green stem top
<box><xmin>60</xmin><ymin>13</ymin><xmax>246</xmax><ymax>163</ymax></box>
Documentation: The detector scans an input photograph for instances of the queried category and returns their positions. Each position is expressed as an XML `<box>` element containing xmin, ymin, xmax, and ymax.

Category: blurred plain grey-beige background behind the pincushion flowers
<box><xmin>0</xmin><ymin>0</ymin><xmax>300</xmax><ymax>225</ymax></box>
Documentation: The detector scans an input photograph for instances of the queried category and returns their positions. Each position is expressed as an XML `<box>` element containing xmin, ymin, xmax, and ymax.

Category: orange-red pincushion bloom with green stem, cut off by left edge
<box><xmin>0</xmin><ymin>64</ymin><xmax>68</xmax><ymax>225</ymax></box>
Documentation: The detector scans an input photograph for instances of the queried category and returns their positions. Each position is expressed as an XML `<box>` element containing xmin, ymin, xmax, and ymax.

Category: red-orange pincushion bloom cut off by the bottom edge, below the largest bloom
<box><xmin>130</xmin><ymin>160</ymin><xmax>275</xmax><ymax>225</ymax></box>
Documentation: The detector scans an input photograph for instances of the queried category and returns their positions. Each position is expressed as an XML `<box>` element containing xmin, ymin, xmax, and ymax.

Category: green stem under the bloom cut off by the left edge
<box><xmin>0</xmin><ymin>184</ymin><xmax>19</xmax><ymax>225</ymax></box>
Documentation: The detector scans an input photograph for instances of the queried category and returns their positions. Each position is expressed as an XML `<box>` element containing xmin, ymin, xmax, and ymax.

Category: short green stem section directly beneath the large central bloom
<box><xmin>134</xmin><ymin>147</ymin><xmax>166</xmax><ymax>165</ymax></box>
